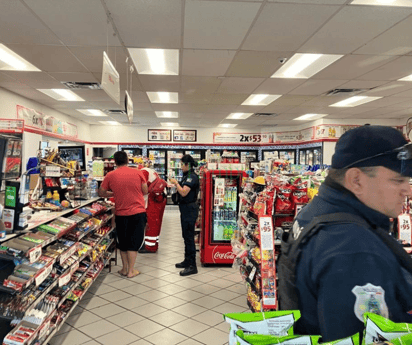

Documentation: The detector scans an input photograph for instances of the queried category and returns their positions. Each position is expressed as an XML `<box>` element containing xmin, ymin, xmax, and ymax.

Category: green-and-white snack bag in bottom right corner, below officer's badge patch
<box><xmin>362</xmin><ymin>313</ymin><xmax>412</xmax><ymax>345</ymax></box>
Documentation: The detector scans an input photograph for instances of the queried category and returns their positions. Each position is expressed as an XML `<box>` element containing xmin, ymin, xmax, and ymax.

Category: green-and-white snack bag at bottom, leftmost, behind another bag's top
<box><xmin>224</xmin><ymin>310</ymin><xmax>300</xmax><ymax>345</ymax></box>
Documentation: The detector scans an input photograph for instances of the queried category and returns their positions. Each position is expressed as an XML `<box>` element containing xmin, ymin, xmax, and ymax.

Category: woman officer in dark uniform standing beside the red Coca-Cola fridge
<box><xmin>170</xmin><ymin>155</ymin><xmax>199</xmax><ymax>276</ymax></box>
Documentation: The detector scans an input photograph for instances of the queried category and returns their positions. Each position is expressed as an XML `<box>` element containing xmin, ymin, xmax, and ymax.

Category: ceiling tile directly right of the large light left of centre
<box><xmin>182</xmin><ymin>49</ymin><xmax>236</xmax><ymax>77</ymax></box>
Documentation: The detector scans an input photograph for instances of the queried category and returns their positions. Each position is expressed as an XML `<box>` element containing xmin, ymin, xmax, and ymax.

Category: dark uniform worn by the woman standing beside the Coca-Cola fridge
<box><xmin>179</xmin><ymin>171</ymin><xmax>199</xmax><ymax>266</ymax></box>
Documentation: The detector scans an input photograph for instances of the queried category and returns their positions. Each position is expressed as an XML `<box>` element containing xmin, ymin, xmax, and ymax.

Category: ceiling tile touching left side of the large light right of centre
<box><xmin>226</xmin><ymin>50</ymin><xmax>293</xmax><ymax>78</ymax></box>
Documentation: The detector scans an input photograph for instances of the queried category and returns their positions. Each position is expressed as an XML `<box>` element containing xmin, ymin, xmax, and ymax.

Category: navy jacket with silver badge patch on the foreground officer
<box><xmin>294</xmin><ymin>179</ymin><xmax>412</xmax><ymax>341</ymax></box>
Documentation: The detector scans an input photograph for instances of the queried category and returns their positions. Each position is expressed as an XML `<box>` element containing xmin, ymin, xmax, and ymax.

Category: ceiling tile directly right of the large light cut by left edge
<box><xmin>8</xmin><ymin>44</ymin><xmax>87</xmax><ymax>72</ymax></box>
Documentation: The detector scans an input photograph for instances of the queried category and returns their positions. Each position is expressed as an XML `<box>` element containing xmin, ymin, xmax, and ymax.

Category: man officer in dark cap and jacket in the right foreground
<box><xmin>278</xmin><ymin>126</ymin><xmax>412</xmax><ymax>342</ymax></box>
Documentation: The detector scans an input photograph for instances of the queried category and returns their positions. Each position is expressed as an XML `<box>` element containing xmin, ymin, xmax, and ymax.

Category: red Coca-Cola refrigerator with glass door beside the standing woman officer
<box><xmin>200</xmin><ymin>170</ymin><xmax>247</xmax><ymax>265</ymax></box>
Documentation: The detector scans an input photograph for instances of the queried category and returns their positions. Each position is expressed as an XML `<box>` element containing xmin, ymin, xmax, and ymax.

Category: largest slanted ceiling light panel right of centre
<box><xmin>271</xmin><ymin>53</ymin><xmax>343</xmax><ymax>79</ymax></box>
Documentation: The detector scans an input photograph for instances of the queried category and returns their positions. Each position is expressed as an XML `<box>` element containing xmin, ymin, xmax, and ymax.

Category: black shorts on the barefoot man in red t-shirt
<box><xmin>115</xmin><ymin>212</ymin><xmax>147</xmax><ymax>252</ymax></box>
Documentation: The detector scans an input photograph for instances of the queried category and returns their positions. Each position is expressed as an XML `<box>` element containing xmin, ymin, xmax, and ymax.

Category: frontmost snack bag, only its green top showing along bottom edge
<box><xmin>235</xmin><ymin>331</ymin><xmax>320</xmax><ymax>345</ymax></box>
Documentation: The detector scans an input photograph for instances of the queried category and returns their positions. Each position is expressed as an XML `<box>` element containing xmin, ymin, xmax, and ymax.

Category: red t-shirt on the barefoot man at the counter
<box><xmin>101</xmin><ymin>166</ymin><xmax>146</xmax><ymax>216</ymax></box>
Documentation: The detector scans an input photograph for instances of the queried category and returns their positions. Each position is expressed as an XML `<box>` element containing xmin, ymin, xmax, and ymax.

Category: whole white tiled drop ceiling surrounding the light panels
<box><xmin>0</xmin><ymin>0</ymin><xmax>412</xmax><ymax>129</ymax></box>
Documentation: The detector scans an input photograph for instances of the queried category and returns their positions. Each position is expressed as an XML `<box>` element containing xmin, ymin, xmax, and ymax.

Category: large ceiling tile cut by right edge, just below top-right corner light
<box><xmin>355</xmin><ymin>17</ymin><xmax>412</xmax><ymax>55</ymax></box>
